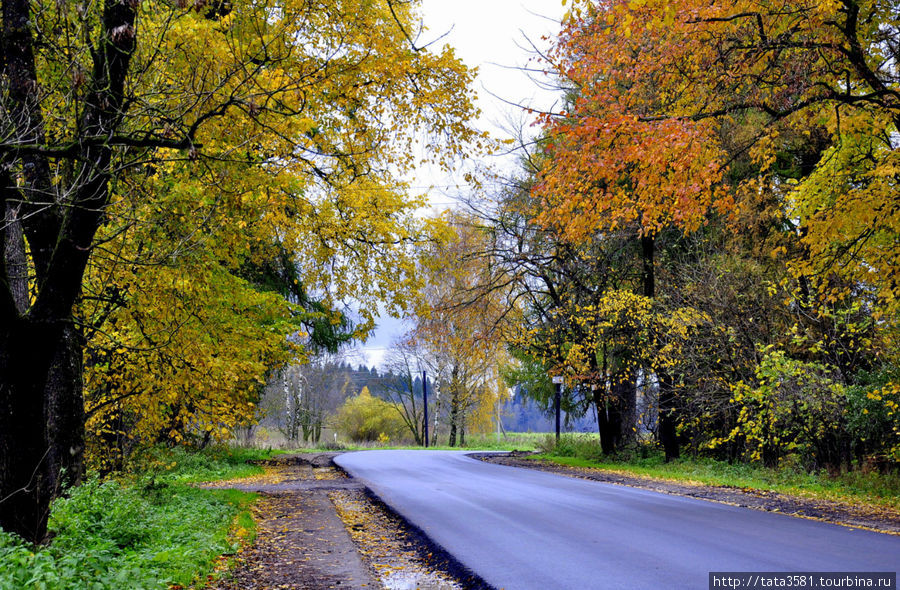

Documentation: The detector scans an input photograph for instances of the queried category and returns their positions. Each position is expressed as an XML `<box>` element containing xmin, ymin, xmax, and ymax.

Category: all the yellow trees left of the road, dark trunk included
<box><xmin>0</xmin><ymin>0</ymin><xmax>479</xmax><ymax>539</ymax></box>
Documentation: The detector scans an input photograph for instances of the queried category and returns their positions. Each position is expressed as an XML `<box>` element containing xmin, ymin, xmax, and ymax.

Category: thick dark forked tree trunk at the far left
<box><xmin>0</xmin><ymin>0</ymin><xmax>136</xmax><ymax>542</ymax></box>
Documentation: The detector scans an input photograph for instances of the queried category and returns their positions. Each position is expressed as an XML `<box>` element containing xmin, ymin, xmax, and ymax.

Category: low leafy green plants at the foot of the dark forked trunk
<box><xmin>0</xmin><ymin>472</ymin><xmax>246</xmax><ymax>590</ymax></box>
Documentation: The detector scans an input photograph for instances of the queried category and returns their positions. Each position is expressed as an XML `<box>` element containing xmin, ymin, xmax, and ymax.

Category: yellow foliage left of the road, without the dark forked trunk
<box><xmin>57</xmin><ymin>0</ymin><xmax>484</xmax><ymax>468</ymax></box>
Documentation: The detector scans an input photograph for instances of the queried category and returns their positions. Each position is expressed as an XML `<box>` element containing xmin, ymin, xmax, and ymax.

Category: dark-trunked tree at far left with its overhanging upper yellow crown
<box><xmin>0</xmin><ymin>0</ymin><xmax>474</xmax><ymax>541</ymax></box>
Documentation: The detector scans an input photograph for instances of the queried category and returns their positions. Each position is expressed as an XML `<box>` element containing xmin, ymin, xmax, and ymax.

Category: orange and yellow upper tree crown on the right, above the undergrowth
<box><xmin>536</xmin><ymin>0</ymin><xmax>900</xmax><ymax>456</ymax></box>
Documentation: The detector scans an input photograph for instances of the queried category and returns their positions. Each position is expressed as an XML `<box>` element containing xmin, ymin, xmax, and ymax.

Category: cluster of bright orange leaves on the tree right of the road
<box><xmin>534</xmin><ymin>1</ymin><xmax>730</xmax><ymax>241</ymax></box>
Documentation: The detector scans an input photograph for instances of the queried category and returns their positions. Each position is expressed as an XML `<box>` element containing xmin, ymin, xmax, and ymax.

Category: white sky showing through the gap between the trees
<box><xmin>352</xmin><ymin>0</ymin><xmax>563</xmax><ymax>366</ymax></box>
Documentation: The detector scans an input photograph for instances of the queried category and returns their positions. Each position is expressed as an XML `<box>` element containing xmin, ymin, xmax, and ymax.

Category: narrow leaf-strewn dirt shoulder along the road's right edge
<box><xmin>475</xmin><ymin>453</ymin><xmax>900</xmax><ymax>535</ymax></box>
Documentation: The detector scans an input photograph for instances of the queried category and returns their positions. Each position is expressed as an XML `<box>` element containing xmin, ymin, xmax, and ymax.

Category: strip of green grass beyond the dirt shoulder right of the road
<box><xmin>530</xmin><ymin>436</ymin><xmax>900</xmax><ymax>510</ymax></box>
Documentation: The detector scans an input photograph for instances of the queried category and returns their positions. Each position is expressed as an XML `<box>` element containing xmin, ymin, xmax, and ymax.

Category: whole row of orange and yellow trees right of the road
<box><xmin>448</xmin><ymin>0</ymin><xmax>900</xmax><ymax>471</ymax></box>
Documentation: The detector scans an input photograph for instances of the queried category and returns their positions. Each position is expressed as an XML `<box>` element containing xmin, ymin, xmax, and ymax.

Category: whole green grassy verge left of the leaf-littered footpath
<box><xmin>0</xmin><ymin>449</ymin><xmax>264</xmax><ymax>590</ymax></box>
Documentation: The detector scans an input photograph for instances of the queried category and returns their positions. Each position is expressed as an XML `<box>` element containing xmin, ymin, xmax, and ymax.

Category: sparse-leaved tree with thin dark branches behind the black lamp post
<box><xmin>480</xmin><ymin>171</ymin><xmax>652</xmax><ymax>452</ymax></box>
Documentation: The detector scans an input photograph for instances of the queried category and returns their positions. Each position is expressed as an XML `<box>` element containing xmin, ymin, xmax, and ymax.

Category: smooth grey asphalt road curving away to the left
<box><xmin>335</xmin><ymin>451</ymin><xmax>900</xmax><ymax>590</ymax></box>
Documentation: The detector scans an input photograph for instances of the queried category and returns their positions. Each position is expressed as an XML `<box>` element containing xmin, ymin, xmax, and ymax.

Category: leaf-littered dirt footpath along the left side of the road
<box><xmin>208</xmin><ymin>453</ymin><xmax>464</xmax><ymax>590</ymax></box>
